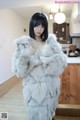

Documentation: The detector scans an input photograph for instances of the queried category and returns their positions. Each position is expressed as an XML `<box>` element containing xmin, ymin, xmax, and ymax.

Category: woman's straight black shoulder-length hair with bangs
<box><xmin>29</xmin><ymin>13</ymin><xmax>48</xmax><ymax>41</ymax></box>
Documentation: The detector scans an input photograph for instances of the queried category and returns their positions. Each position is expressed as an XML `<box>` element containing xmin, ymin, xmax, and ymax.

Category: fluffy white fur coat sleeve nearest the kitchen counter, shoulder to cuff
<box><xmin>41</xmin><ymin>34</ymin><xmax>67</xmax><ymax>75</ymax></box>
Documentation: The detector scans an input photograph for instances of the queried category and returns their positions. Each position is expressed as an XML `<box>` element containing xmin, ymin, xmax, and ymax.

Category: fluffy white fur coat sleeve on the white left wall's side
<box><xmin>12</xmin><ymin>36</ymin><xmax>35</xmax><ymax>78</ymax></box>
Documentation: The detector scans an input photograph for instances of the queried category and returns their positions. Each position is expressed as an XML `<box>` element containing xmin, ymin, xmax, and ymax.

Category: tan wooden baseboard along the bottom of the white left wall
<box><xmin>0</xmin><ymin>76</ymin><xmax>20</xmax><ymax>97</ymax></box>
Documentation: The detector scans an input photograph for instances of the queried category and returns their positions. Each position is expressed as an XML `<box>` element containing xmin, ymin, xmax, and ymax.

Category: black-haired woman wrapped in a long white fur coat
<box><xmin>12</xmin><ymin>13</ymin><xmax>66</xmax><ymax>120</ymax></box>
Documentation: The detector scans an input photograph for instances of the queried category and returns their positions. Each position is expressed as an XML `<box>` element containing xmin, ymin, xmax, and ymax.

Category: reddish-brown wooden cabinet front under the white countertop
<box><xmin>59</xmin><ymin>64</ymin><xmax>80</xmax><ymax>104</ymax></box>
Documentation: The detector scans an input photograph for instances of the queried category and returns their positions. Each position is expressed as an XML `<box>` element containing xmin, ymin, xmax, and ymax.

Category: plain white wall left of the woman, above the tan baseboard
<box><xmin>0</xmin><ymin>9</ymin><xmax>27</xmax><ymax>84</ymax></box>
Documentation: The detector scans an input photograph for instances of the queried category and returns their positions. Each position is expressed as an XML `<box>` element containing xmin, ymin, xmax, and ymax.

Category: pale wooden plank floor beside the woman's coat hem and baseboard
<box><xmin>0</xmin><ymin>82</ymin><xmax>80</xmax><ymax>120</ymax></box>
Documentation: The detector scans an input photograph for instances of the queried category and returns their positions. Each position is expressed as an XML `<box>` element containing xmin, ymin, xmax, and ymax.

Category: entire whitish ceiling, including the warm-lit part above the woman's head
<box><xmin>0</xmin><ymin>0</ymin><xmax>73</xmax><ymax>18</ymax></box>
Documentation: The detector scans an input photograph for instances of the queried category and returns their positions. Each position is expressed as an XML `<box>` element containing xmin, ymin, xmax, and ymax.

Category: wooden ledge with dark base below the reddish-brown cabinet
<box><xmin>56</xmin><ymin>104</ymin><xmax>80</xmax><ymax>117</ymax></box>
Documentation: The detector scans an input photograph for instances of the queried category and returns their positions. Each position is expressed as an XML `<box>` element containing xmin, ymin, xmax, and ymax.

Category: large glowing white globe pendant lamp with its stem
<box><xmin>54</xmin><ymin>7</ymin><xmax>66</xmax><ymax>24</ymax></box>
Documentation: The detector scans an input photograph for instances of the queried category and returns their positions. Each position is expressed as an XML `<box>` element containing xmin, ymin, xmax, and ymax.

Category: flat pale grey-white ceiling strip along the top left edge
<box><xmin>0</xmin><ymin>0</ymin><xmax>55</xmax><ymax>8</ymax></box>
